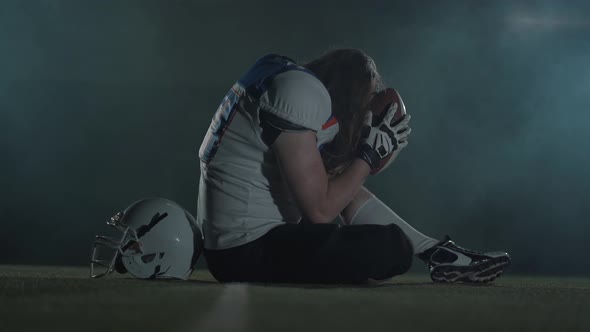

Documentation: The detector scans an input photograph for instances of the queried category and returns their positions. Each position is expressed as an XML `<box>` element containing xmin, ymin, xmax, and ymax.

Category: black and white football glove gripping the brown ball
<box><xmin>359</xmin><ymin>103</ymin><xmax>412</xmax><ymax>170</ymax></box>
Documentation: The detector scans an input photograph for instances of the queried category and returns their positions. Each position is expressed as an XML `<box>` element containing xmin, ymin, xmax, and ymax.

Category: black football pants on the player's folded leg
<box><xmin>205</xmin><ymin>224</ymin><xmax>413</xmax><ymax>283</ymax></box>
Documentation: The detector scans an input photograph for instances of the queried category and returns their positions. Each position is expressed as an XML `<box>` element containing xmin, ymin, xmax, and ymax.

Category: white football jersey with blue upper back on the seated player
<box><xmin>197</xmin><ymin>70</ymin><xmax>338</xmax><ymax>249</ymax></box>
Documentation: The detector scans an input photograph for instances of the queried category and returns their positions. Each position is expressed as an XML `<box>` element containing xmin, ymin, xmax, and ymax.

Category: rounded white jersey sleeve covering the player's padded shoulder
<box><xmin>260</xmin><ymin>70</ymin><xmax>332</xmax><ymax>132</ymax></box>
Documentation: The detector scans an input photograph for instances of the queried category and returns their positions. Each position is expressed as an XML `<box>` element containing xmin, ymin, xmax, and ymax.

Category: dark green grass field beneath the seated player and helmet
<box><xmin>0</xmin><ymin>266</ymin><xmax>590</xmax><ymax>332</ymax></box>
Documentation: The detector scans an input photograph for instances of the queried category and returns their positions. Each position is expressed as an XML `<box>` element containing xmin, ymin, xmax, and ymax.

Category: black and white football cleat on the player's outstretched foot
<box><xmin>418</xmin><ymin>235</ymin><xmax>510</xmax><ymax>283</ymax></box>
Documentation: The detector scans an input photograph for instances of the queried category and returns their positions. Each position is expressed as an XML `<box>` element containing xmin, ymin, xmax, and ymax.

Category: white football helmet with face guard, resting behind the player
<box><xmin>90</xmin><ymin>198</ymin><xmax>203</xmax><ymax>280</ymax></box>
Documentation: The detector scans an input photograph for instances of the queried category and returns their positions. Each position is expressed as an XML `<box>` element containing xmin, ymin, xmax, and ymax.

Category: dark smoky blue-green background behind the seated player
<box><xmin>0</xmin><ymin>0</ymin><xmax>590</xmax><ymax>275</ymax></box>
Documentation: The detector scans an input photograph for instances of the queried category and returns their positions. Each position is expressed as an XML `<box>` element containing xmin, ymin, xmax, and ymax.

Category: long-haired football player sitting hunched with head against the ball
<box><xmin>197</xmin><ymin>49</ymin><xmax>510</xmax><ymax>283</ymax></box>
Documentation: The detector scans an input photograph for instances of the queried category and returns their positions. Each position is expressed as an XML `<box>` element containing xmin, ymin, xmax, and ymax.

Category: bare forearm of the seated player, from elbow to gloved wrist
<box><xmin>310</xmin><ymin>159</ymin><xmax>371</xmax><ymax>223</ymax></box>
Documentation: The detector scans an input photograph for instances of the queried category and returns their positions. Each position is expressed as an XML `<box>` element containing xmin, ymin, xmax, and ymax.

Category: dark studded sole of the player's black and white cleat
<box><xmin>430</xmin><ymin>256</ymin><xmax>510</xmax><ymax>283</ymax></box>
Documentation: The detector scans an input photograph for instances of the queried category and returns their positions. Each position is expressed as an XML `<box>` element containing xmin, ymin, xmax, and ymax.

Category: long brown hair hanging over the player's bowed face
<box><xmin>303</xmin><ymin>48</ymin><xmax>382</xmax><ymax>175</ymax></box>
